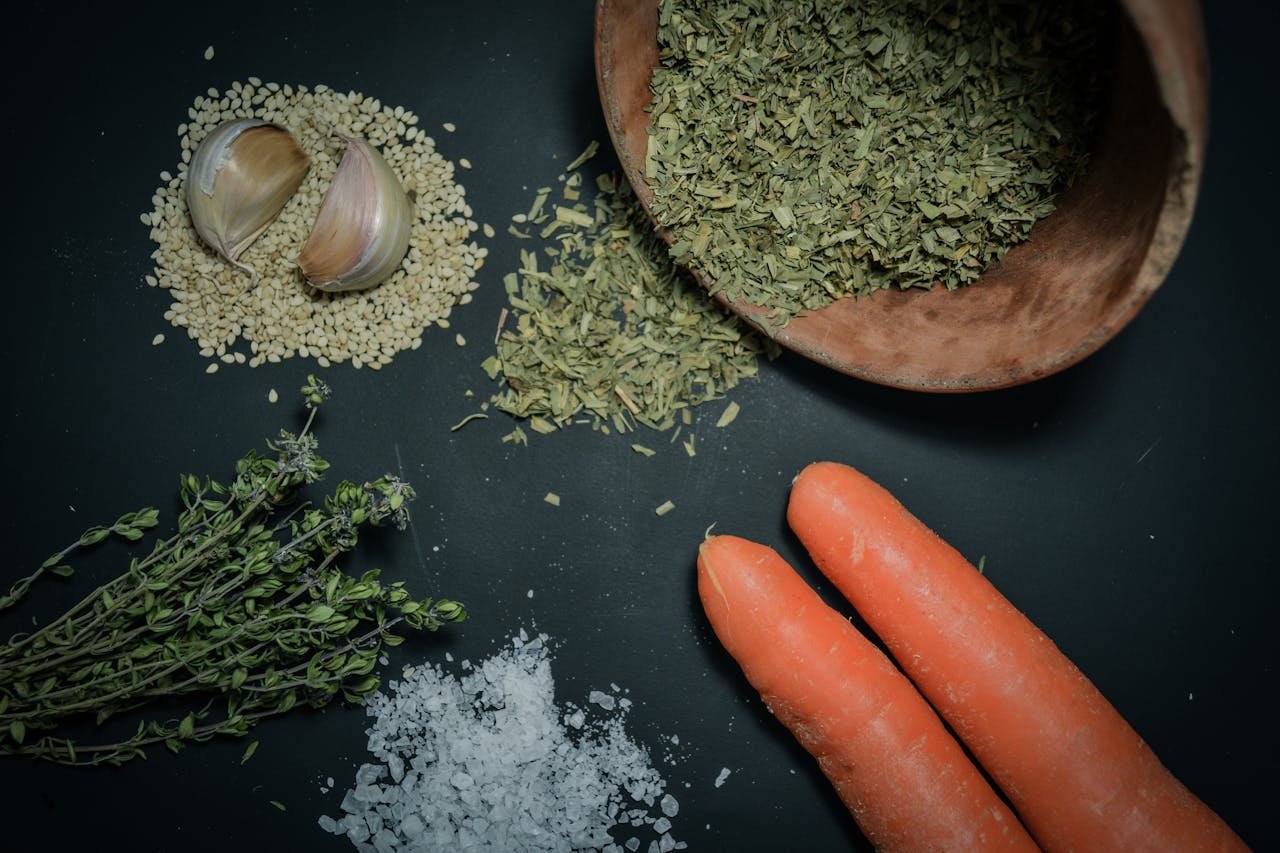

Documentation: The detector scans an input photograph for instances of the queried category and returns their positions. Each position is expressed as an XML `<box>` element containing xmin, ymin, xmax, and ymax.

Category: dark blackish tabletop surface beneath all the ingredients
<box><xmin>0</xmin><ymin>0</ymin><xmax>1280</xmax><ymax>850</ymax></box>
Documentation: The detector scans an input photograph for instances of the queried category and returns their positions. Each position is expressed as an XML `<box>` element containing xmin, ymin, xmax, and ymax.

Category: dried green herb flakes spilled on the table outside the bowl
<box><xmin>484</xmin><ymin>145</ymin><xmax>777</xmax><ymax>441</ymax></box>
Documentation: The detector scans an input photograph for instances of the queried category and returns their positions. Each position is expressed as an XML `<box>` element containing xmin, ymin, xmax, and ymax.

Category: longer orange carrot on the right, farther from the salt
<box><xmin>787</xmin><ymin>462</ymin><xmax>1247</xmax><ymax>850</ymax></box>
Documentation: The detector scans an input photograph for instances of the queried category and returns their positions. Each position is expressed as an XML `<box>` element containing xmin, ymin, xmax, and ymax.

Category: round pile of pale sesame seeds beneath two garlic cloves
<box><xmin>141</xmin><ymin>77</ymin><xmax>488</xmax><ymax>373</ymax></box>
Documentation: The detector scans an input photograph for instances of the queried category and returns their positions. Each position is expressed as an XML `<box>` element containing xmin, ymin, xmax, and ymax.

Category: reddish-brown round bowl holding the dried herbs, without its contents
<box><xmin>595</xmin><ymin>0</ymin><xmax>1208</xmax><ymax>392</ymax></box>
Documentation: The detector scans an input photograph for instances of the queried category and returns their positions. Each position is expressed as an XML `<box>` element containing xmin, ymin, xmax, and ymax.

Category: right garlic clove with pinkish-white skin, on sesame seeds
<box><xmin>294</xmin><ymin>134</ymin><xmax>413</xmax><ymax>292</ymax></box>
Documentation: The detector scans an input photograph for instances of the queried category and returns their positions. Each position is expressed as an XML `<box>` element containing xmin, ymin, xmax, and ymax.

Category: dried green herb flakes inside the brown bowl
<box><xmin>646</xmin><ymin>0</ymin><xmax>1101</xmax><ymax>324</ymax></box>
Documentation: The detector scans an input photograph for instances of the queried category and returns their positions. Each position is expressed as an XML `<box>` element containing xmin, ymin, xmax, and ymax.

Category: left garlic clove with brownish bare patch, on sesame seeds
<box><xmin>187</xmin><ymin>119</ymin><xmax>311</xmax><ymax>279</ymax></box>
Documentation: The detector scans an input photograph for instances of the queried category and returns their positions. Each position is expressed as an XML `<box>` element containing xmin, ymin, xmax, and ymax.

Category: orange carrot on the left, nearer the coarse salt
<box><xmin>698</xmin><ymin>537</ymin><xmax>1038</xmax><ymax>850</ymax></box>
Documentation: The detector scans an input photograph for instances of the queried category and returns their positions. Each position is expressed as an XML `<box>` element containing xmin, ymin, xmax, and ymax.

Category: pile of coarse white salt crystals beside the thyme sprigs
<box><xmin>320</xmin><ymin>630</ymin><xmax>686</xmax><ymax>853</ymax></box>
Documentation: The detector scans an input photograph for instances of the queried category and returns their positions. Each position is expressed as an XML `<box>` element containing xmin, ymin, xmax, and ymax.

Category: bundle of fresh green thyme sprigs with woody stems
<box><xmin>0</xmin><ymin>379</ymin><xmax>465</xmax><ymax>766</ymax></box>
